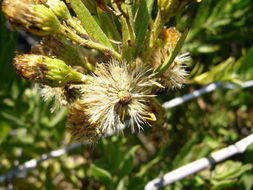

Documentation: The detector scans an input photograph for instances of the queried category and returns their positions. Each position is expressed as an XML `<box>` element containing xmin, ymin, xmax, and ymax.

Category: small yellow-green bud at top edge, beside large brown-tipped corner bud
<box><xmin>43</xmin><ymin>0</ymin><xmax>71</xmax><ymax>20</ymax></box>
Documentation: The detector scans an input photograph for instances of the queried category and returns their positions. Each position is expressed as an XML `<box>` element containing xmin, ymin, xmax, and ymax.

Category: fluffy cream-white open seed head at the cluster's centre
<box><xmin>82</xmin><ymin>61</ymin><xmax>156</xmax><ymax>132</ymax></box>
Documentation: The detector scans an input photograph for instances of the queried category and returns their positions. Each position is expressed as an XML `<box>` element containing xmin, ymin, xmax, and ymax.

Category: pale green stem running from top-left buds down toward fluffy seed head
<box><xmin>60</xmin><ymin>25</ymin><xmax>121</xmax><ymax>60</ymax></box>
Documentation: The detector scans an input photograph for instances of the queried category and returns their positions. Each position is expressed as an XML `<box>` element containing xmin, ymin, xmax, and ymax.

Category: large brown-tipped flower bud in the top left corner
<box><xmin>2</xmin><ymin>0</ymin><xmax>60</xmax><ymax>36</ymax></box>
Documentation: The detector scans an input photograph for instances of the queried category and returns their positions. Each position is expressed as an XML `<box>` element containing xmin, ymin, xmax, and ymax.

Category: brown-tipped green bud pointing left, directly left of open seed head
<box><xmin>14</xmin><ymin>54</ymin><xmax>87</xmax><ymax>87</ymax></box>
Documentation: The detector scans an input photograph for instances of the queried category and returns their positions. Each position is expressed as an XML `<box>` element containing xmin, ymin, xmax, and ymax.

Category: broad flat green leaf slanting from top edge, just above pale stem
<box><xmin>71</xmin><ymin>0</ymin><xmax>113</xmax><ymax>48</ymax></box>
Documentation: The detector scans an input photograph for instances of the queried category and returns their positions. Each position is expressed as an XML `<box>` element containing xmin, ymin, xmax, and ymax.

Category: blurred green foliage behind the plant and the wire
<box><xmin>0</xmin><ymin>0</ymin><xmax>253</xmax><ymax>190</ymax></box>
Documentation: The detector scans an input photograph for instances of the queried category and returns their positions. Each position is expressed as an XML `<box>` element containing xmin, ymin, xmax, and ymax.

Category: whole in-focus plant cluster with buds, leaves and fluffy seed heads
<box><xmin>2</xmin><ymin>0</ymin><xmax>196</xmax><ymax>143</ymax></box>
